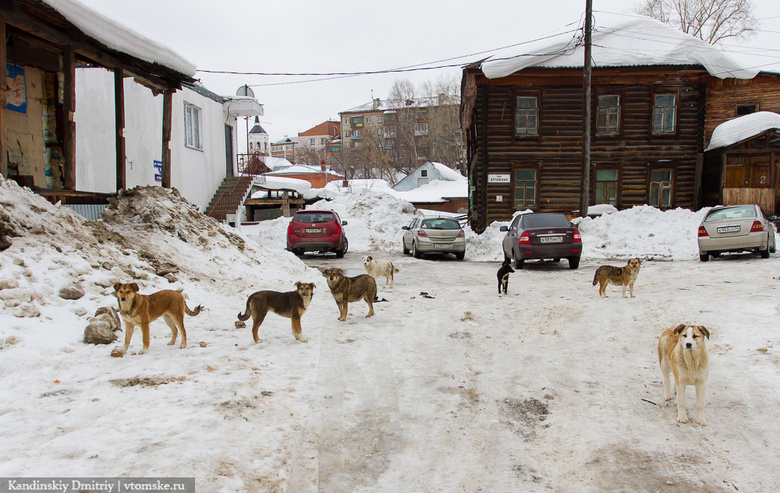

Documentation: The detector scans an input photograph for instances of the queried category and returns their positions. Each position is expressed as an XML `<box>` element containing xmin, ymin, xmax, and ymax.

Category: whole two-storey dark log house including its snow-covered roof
<box><xmin>461</xmin><ymin>13</ymin><xmax>780</xmax><ymax>232</ymax></box>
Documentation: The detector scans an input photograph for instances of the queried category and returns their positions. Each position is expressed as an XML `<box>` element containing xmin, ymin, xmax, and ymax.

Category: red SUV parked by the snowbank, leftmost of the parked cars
<box><xmin>287</xmin><ymin>210</ymin><xmax>349</xmax><ymax>258</ymax></box>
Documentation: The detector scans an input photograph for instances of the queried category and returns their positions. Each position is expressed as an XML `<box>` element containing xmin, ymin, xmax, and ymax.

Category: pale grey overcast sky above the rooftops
<box><xmin>78</xmin><ymin>0</ymin><xmax>780</xmax><ymax>146</ymax></box>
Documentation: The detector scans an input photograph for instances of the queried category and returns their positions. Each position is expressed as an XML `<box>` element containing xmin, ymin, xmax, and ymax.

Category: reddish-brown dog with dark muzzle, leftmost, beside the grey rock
<box><xmin>114</xmin><ymin>282</ymin><xmax>203</xmax><ymax>354</ymax></box>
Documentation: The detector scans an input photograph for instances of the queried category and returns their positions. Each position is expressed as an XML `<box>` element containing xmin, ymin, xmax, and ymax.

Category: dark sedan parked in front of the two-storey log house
<box><xmin>500</xmin><ymin>212</ymin><xmax>582</xmax><ymax>269</ymax></box>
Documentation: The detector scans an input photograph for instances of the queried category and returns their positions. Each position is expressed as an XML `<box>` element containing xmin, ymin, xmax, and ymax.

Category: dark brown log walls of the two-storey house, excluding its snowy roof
<box><xmin>462</xmin><ymin>66</ymin><xmax>709</xmax><ymax>232</ymax></box>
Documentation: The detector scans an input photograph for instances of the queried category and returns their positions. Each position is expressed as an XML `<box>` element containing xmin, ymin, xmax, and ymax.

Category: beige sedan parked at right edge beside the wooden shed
<box><xmin>699</xmin><ymin>204</ymin><xmax>777</xmax><ymax>262</ymax></box>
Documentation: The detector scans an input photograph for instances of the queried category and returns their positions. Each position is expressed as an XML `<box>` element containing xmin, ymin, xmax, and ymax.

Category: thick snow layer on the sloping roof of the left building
<box><xmin>43</xmin><ymin>0</ymin><xmax>197</xmax><ymax>77</ymax></box>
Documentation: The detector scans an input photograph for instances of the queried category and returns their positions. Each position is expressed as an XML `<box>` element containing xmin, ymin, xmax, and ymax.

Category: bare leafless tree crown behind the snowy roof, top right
<box><xmin>634</xmin><ymin>0</ymin><xmax>759</xmax><ymax>44</ymax></box>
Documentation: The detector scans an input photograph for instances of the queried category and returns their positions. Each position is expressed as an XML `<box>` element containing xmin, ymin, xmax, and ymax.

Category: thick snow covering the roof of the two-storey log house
<box><xmin>482</xmin><ymin>13</ymin><xmax>758</xmax><ymax>79</ymax></box>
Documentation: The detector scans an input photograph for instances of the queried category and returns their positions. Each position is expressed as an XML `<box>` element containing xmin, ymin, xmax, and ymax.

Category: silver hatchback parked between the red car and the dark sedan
<box><xmin>401</xmin><ymin>217</ymin><xmax>466</xmax><ymax>260</ymax></box>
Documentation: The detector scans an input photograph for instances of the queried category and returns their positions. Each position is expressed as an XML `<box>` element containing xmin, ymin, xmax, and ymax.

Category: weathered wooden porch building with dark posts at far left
<box><xmin>0</xmin><ymin>0</ymin><xmax>194</xmax><ymax>203</ymax></box>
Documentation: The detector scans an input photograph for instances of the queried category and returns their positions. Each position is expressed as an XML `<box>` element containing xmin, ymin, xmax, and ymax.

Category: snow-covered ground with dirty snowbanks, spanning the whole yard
<box><xmin>0</xmin><ymin>180</ymin><xmax>780</xmax><ymax>492</ymax></box>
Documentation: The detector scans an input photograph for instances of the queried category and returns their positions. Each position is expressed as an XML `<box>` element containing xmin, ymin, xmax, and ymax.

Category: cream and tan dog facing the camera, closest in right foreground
<box><xmin>658</xmin><ymin>324</ymin><xmax>710</xmax><ymax>426</ymax></box>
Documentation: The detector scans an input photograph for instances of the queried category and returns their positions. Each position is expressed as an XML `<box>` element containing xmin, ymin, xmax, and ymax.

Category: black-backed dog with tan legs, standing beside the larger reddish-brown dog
<box><xmin>238</xmin><ymin>281</ymin><xmax>316</xmax><ymax>343</ymax></box>
